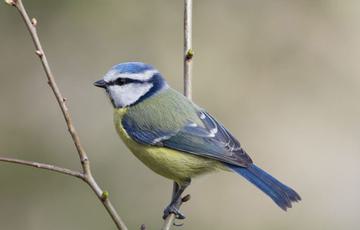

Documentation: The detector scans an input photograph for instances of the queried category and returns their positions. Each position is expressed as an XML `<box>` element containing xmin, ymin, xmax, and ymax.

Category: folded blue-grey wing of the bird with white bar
<box><xmin>122</xmin><ymin>111</ymin><xmax>252</xmax><ymax>167</ymax></box>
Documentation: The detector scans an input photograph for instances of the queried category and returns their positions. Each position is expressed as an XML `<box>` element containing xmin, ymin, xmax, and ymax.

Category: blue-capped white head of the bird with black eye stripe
<box><xmin>94</xmin><ymin>62</ymin><xmax>168</xmax><ymax>108</ymax></box>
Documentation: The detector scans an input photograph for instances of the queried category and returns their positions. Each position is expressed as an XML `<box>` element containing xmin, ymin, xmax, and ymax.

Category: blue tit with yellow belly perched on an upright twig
<box><xmin>94</xmin><ymin>62</ymin><xmax>301</xmax><ymax>219</ymax></box>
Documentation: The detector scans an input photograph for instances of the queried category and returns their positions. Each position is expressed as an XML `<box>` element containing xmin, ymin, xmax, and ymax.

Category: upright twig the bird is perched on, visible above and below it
<box><xmin>161</xmin><ymin>0</ymin><xmax>194</xmax><ymax>230</ymax></box>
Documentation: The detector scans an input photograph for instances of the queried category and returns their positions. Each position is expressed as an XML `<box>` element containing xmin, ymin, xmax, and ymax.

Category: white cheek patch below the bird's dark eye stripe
<box><xmin>108</xmin><ymin>83</ymin><xmax>153</xmax><ymax>107</ymax></box>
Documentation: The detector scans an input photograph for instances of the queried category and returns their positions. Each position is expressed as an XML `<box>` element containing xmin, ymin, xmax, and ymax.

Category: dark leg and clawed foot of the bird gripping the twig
<box><xmin>163</xmin><ymin>180</ymin><xmax>190</xmax><ymax>219</ymax></box>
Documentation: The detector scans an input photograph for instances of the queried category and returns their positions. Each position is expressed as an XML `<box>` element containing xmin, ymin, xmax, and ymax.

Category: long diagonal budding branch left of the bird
<box><xmin>5</xmin><ymin>0</ymin><xmax>127</xmax><ymax>230</ymax></box>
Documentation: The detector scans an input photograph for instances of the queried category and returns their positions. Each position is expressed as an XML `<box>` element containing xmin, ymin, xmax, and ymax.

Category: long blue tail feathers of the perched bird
<box><xmin>226</xmin><ymin>164</ymin><xmax>301</xmax><ymax>211</ymax></box>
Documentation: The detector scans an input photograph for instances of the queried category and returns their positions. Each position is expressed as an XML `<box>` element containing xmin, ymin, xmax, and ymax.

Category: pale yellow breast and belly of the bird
<box><xmin>114</xmin><ymin>108</ymin><xmax>225</xmax><ymax>183</ymax></box>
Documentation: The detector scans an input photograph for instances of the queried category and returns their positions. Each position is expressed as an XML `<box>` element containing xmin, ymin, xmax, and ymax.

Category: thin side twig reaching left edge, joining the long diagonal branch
<box><xmin>0</xmin><ymin>157</ymin><xmax>84</xmax><ymax>179</ymax></box>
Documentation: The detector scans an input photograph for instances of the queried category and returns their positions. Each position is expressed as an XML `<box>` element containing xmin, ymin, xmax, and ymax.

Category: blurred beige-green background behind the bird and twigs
<box><xmin>0</xmin><ymin>0</ymin><xmax>360</xmax><ymax>230</ymax></box>
